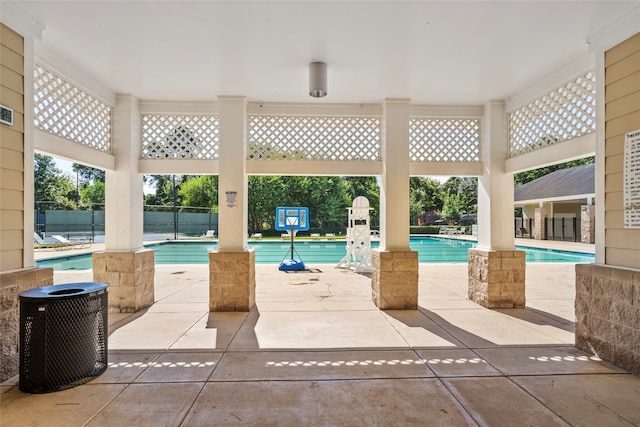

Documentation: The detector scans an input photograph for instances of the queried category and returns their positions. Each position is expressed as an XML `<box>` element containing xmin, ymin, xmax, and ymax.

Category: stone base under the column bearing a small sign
<box><xmin>209</xmin><ymin>250</ymin><xmax>256</xmax><ymax>311</ymax></box>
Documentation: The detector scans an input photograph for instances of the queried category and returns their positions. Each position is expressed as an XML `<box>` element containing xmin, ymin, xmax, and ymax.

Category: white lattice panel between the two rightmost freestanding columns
<box><xmin>409</xmin><ymin>118</ymin><xmax>480</xmax><ymax>162</ymax></box>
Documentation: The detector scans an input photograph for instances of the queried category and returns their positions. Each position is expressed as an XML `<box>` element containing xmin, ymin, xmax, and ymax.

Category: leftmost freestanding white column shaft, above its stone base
<box><xmin>105</xmin><ymin>95</ymin><xmax>143</xmax><ymax>251</ymax></box>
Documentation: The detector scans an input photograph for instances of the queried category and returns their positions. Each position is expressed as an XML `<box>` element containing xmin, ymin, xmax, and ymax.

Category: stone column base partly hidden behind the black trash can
<box><xmin>93</xmin><ymin>249</ymin><xmax>155</xmax><ymax>313</ymax></box>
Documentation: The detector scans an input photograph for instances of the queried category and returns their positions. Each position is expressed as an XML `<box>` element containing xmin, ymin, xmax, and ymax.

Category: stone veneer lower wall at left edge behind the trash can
<box><xmin>0</xmin><ymin>267</ymin><xmax>53</xmax><ymax>382</ymax></box>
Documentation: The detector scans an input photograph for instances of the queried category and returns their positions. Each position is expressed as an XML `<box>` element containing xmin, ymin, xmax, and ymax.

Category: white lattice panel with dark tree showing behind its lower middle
<box><xmin>141</xmin><ymin>114</ymin><xmax>220</xmax><ymax>159</ymax></box>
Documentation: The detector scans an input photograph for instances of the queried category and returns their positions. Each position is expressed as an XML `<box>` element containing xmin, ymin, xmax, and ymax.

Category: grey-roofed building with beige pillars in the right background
<box><xmin>514</xmin><ymin>164</ymin><xmax>596</xmax><ymax>243</ymax></box>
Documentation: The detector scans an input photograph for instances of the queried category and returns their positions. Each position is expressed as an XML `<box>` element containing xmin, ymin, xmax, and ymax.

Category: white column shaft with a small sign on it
<box><xmin>218</xmin><ymin>96</ymin><xmax>248</xmax><ymax>252</ymax></box>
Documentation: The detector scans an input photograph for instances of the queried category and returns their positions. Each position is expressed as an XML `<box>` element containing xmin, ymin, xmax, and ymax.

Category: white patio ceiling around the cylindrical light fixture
<box><xmin>12</xmin><ymin>1</ymin><xmax>638</xmax><ymax>105</ymax></box>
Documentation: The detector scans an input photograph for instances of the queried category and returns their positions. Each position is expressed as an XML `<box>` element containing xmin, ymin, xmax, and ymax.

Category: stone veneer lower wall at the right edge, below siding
<box><xmin>575</xmin><ymin>264</ymin><xmax>640</xmax><ymax>375</ymax></box>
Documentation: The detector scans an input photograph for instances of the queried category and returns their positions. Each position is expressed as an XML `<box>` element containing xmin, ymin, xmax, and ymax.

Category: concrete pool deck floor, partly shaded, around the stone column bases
<box><xmin>0</xmin><ymin>239</ymin><xmax>640</xmax><ymax>426</ymax></box>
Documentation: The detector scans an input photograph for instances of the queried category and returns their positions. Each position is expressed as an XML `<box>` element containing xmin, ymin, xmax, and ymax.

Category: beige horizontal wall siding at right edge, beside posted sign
<box><xmin>605</xmin><ymin>33</ymin><xmax>640</xmax><ymax>268</ymax></box>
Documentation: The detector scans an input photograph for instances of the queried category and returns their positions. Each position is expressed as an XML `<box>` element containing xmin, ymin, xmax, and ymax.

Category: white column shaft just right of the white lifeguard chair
<box><xmin>380</xmin><ymin>99</ymin><xmax>410</xmax><ymax>251</ymax></box>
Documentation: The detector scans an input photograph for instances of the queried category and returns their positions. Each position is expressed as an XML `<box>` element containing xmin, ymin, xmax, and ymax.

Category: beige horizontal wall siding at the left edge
<box><xmin>0</xmin><ymin>24</ymin><xmax>24</xmax><ymax>271</ymax></box>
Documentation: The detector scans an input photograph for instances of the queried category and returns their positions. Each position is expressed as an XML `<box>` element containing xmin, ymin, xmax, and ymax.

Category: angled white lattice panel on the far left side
<box><xmin>33</xmin><ymin>64</ymin><xmax>111</xmax><ymax>153</ymax></box>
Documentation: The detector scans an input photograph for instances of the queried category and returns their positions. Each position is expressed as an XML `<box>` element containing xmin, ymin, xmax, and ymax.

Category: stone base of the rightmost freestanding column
<box><xmin>468</xmin><ymin>248</ymin><xmax>525</xmax><ymax>308</ymax></box>
